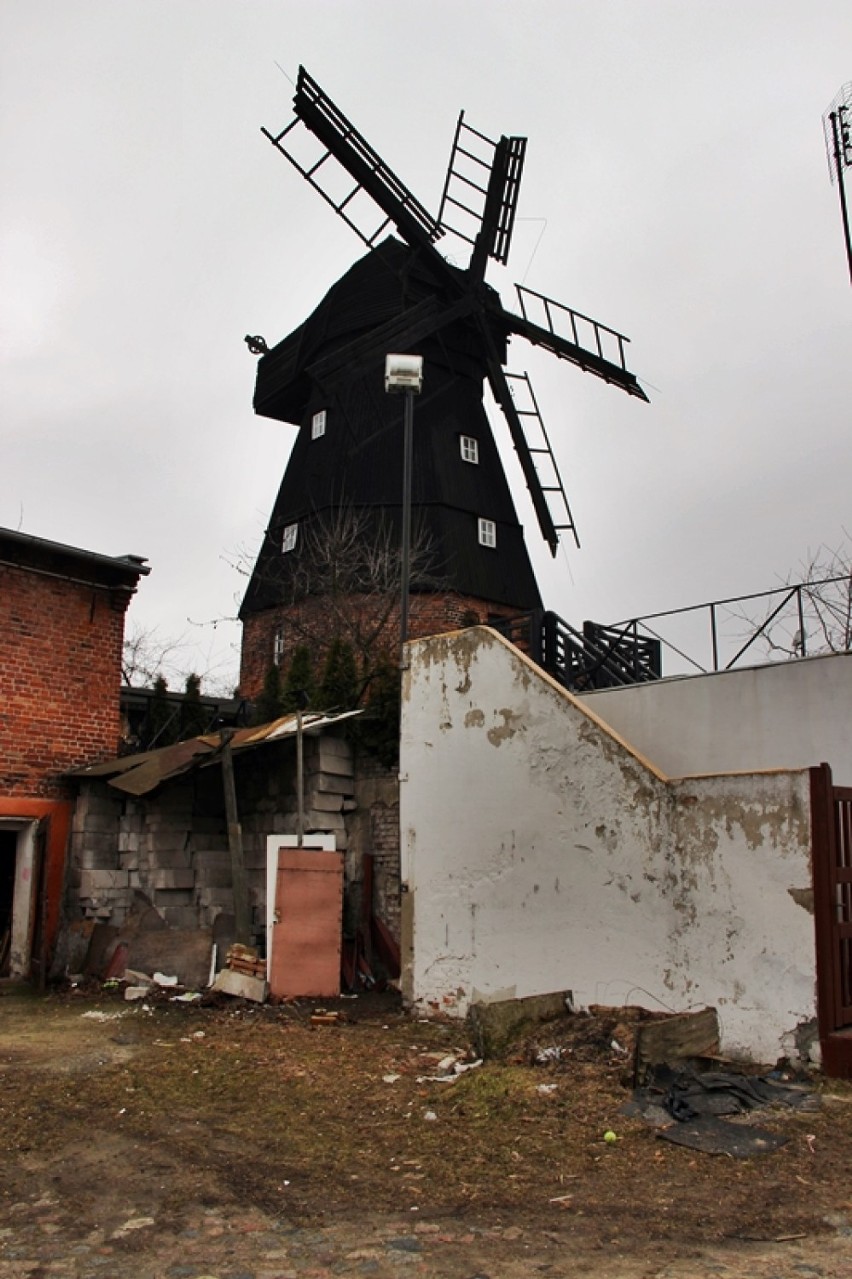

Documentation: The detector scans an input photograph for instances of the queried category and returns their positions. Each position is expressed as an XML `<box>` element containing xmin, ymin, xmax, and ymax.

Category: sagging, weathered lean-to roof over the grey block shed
<box><xmin>69</xmin><ymin>710</ymin><xmax>362</xmax><ymax>796</ymax></box>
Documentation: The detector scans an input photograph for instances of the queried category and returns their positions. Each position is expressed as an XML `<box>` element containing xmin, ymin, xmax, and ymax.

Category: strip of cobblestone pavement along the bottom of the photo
<box><xmin>0</xmin><ymin>1196</ymin><xmax>852</xmax><ymax>1279</ymax></box>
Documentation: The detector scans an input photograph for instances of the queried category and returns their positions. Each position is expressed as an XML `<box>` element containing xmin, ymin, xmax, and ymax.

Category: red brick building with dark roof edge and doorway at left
<box><xmin>0</xmin><ymin>528</ymin><xmax>148</xmax><ymax>977</ymax></box>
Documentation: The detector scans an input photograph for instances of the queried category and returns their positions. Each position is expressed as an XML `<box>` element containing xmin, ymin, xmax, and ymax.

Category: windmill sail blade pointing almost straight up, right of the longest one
<box><xmin>438</xmin><ymin>111</ymin><xmax>527</xmax><ymax>280</ymax></box>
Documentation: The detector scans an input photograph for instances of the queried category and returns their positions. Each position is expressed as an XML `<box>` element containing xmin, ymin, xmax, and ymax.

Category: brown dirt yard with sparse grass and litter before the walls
<box><xmin>0</xmin><ymin>990</ymin><xmax>852</xmax><ymax>1274</ymax></box>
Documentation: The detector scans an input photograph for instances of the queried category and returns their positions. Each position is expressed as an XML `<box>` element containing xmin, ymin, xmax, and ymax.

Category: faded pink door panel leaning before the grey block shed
<box><xmin>269</xmin><ymin>848</ymin><xmax>343</xmax><ymax>999</ymax></box>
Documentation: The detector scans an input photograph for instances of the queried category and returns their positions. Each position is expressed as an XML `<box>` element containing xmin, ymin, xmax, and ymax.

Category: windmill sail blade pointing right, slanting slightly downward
<box><xmin>503</xmin><ymin>284</ymin><xmax>647</xmax><ymax>403</ymax></box>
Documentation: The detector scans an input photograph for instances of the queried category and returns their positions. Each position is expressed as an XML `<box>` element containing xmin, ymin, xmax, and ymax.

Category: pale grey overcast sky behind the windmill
<box><xmin>0</xmin><ymin>0</ymin><xmax>852</xmax><ymax>680</ymax></box>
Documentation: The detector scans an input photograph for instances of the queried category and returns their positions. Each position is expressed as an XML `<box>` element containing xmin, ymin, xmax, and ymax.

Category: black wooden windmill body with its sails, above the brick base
<box><xmin>241</xmin><ymin>67</ymin><xmax>647</xmax><ymax>683</ymax></box>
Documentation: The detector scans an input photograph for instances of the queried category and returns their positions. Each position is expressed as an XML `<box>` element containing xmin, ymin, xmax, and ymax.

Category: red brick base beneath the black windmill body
<box><xmin>239</xmin><ymin>592</ymin><xmax>517</xmax><ymax>700</ymax></box>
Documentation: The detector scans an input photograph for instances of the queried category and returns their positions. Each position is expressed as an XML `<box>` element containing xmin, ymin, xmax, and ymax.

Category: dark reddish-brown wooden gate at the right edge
<box><xmin>811</xmin><ymin>764</ymin><xmax>852</xmax><ymax>1078</ymax></box>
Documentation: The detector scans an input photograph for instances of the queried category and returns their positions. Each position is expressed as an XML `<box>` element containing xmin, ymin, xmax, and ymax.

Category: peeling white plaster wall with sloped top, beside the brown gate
<box><xmin>400</xmin><ymin>628</ymin><xmax>815</xmax><ymax>1060</ymax></box>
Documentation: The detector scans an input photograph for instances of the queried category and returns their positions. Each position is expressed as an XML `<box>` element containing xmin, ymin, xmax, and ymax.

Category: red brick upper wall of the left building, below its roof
<box><xmin>0</xmin><ymin>565</ymin><xmax>129</xmax><ymax>797</ymax></box>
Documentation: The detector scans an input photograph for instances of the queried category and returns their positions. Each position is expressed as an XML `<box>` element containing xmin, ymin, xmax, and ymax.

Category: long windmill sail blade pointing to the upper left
<box><xmin>261</xmin><ymin>67</ymin><xmax>444</xmax><ymax>262</ymax></box>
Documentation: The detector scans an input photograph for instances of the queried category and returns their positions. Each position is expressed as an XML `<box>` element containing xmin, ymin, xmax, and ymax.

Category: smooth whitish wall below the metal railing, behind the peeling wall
<box><xmin>581</xmin><ymin>652</ymin><xmax>852</xmax><ymax>787</ymax></box>
